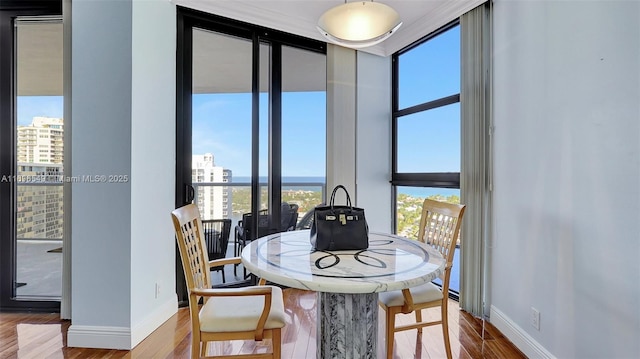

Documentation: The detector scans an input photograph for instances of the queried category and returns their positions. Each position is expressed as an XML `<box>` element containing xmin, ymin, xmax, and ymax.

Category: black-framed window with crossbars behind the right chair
<box><xmin>392</xmin><ymin>22</ymin><xmax>460</xmax><ymax>292</ymax></box>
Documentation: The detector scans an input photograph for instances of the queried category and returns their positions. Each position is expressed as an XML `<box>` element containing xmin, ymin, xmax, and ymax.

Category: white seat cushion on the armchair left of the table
<box><xmin>199</xmin><ymin>286</ymin><xmax>285</xmax><ymax>333</ymax></box>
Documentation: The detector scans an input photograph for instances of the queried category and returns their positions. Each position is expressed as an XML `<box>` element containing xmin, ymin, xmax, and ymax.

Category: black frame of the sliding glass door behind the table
<box><xmin>175</xmin><ymin>6</ymin><xmax>327</xmax><ymax>305</ymax></box>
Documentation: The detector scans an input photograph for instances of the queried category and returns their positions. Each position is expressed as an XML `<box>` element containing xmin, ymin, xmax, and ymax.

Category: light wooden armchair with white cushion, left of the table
<box><xmin>171</xmin><ymin>204</ymin><xmax>285</xmax><ymax>359</ymax></box>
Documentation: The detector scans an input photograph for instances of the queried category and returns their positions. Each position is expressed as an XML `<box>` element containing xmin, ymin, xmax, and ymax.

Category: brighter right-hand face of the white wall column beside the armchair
<box><xmin>130</xmin><ymin>0</ymin><xmax>178</xmax><ymax>346</ymax></box>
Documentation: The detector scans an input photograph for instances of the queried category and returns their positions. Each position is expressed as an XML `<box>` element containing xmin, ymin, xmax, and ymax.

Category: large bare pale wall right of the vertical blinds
<box><xmin>491</xmin><ymin>0</ymin><xmax>640</xmax><ymax>358</ymax></box>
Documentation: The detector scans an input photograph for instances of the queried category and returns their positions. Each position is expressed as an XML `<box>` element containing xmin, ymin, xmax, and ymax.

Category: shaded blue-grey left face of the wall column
<box><xmin>68</xmin><ymin>1</ymin><xmax>131</xmax><ymax>347</ymax></box>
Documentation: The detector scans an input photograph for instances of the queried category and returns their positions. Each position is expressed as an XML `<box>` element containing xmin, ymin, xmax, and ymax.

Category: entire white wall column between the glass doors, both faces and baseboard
<box><xmin>68</xmin><ymin>0</ymin><xmax>177</xmax><ymax>349</ymax></box>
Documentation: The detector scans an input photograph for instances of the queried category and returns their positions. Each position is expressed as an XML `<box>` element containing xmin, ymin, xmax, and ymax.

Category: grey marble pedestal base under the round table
<box><xmin>316</xmin><ymin>292</ymin><xmax>378</xmax><ymax>359</ymax></box>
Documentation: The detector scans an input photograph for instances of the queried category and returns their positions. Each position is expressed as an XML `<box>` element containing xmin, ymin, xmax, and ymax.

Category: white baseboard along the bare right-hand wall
<box><xmin>489</xmin><ymin>305</ymin><xmax>556</xmax><ymax>359</ymax></box>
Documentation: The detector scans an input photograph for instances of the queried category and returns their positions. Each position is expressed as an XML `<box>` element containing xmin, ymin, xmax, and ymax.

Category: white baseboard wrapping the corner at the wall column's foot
<box><xmin>67</xmin><ymin>296</ymin><xmax>178</xmax><ymax>350</ymax></box>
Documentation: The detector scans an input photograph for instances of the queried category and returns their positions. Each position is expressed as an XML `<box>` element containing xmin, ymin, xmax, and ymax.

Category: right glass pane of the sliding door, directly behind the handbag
<box><xmin>282</xmin><ymin>46</ymin><xmax>327</xmax><ymax>226</ymax></box>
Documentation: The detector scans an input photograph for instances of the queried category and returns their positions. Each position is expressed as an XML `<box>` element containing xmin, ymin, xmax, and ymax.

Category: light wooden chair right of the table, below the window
<box><xmin>378</xmin><ymin>199</ymin><xmax>465</xmax><ymax>359</ymax></box>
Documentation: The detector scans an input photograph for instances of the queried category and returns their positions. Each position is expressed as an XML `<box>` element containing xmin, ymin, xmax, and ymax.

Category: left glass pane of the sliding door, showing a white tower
<box><xmin>189</xmin><ymin>28</ymin><xmax>254</xmax><ymax>228</ymax></box>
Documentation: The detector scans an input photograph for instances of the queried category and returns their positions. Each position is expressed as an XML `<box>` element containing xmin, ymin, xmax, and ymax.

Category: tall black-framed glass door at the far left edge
<box><xmin>0</xmin><ymin>1</ymin><xmax>64</xmax><ymax>310</ymax></box>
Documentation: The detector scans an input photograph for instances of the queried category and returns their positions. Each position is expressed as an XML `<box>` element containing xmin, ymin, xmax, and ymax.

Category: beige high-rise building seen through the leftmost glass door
<box><xmin>16</xmin><ymin>117</ymin><xmax>64</xmax><ymax>239</ymax></box>
